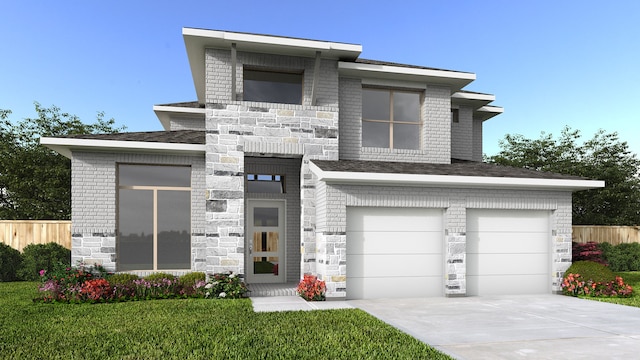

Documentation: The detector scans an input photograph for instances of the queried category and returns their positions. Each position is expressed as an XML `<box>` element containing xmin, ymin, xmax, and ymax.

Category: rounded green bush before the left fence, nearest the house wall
<box><xmin>18</xmin><ymin>242</ymin><xmax>71</xmax><ymax>281</ymax></box>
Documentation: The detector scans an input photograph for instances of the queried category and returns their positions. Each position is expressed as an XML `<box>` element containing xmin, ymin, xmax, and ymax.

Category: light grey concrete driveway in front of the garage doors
<box><xmin>349</xmin><ymin>295</ymin><xmax>640</xmax><ymax>359</ymax></box>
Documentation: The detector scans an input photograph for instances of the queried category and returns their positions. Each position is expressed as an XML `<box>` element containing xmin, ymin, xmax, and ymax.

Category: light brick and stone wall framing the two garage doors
<box><xmin>316</xmin><ymin>184</ymin><xmax>571</xmax><ymax>297</ymax></box>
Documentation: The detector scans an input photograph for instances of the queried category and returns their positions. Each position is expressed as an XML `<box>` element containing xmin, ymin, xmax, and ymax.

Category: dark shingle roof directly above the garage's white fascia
<box><xmin>312</xmin><ymin>159</ymin><xmax>587</xmax><ymax>180</ymax></box>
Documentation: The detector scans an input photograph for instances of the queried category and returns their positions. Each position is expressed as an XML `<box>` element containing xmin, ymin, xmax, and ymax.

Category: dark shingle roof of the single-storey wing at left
<box><xmin>60</xmin><ymin>130</ymin><xmax>205</xmax><ymax>145</ymax></box>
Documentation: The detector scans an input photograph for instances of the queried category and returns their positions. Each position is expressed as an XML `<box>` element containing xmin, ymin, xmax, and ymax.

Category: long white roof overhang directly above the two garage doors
<box><xmin>309</xmin><ymin>162</ymin><xmax>604</xmax><ymax>191</ymax></box>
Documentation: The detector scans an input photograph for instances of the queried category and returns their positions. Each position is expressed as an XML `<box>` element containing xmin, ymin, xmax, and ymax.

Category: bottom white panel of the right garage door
<box><xmin>467</xmin><ymin>275</ymin><xmax>551</xmax><ymax>295</ymax></box>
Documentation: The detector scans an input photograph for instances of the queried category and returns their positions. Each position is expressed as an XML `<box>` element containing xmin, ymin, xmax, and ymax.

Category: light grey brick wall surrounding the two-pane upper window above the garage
<box><xmin>340</xmin><ymin>77</ymin><xmax>450</xmax><ymax>164</ymax></box>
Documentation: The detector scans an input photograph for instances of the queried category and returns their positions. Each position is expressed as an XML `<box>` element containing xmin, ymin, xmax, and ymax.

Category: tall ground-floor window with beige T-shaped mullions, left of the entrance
<box><xmin>117</xmin><ymin>164</ymin><xmax>191</xmax><ymax>271</ymax></box>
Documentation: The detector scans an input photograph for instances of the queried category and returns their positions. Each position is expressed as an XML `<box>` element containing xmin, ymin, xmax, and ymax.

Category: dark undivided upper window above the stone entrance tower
<box><xmin>243</xmin><ymin>69</ymin><xmax>302</xmax><ymax>104</ymax></box>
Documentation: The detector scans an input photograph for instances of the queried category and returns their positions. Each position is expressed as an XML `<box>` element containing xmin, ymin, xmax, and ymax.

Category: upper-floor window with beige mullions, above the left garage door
<box><xmin>362</xmin><ymin>88</ymin><xmax>421</xmax><ymax>150</ymax></box>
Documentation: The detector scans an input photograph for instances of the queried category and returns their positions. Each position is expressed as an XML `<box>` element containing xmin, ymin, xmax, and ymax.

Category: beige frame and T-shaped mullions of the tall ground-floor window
<box><xmin>116</xmin><ymin>163</ymin><xmax>193</xmax><ymax>271</ymax></box>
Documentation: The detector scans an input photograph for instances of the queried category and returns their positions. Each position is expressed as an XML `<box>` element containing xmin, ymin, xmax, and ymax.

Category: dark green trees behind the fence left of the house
<box><xmin>0</xmin><ymin>102</ymin><xmax>124</xmax><ymax>220</ymax></box>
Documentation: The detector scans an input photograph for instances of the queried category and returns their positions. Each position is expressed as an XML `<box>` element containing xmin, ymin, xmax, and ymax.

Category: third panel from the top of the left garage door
<box><xmin>347</xmin><ymin>254</ymin><xmax>442</xmax><ymax>278</ymax></box>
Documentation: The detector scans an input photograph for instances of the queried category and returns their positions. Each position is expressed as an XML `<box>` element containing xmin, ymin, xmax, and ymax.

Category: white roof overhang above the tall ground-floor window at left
<box><xmin>40</xmin><ymin>137</ymin><xmax>205</xmax><ymax>159</ymax></box>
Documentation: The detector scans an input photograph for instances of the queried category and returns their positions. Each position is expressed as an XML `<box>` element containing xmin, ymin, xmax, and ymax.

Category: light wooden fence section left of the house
<box><xmin>0</xmin><ymin>220</ymin><xmax>71</xmax><ymax>251</ymax></box>
